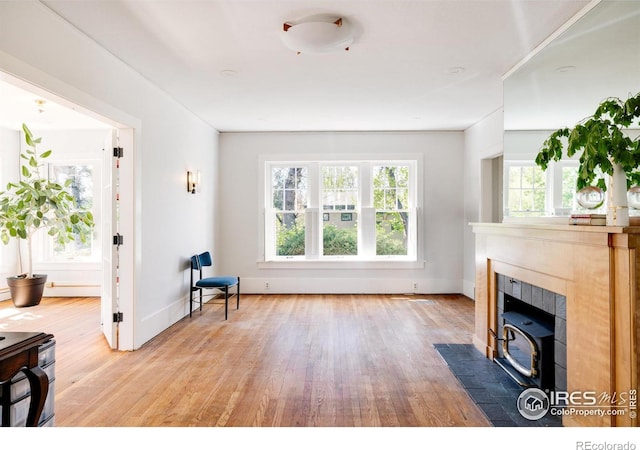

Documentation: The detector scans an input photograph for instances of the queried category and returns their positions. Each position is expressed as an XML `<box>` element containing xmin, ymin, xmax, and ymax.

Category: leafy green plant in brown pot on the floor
<box><xmin>0</xmin><ymin>124</ymin><xmax>94</xmax><ymax>307</ymax></box>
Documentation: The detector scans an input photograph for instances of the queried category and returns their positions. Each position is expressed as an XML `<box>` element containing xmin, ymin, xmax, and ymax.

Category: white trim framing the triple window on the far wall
<box><xmin>256</xmin><ymin>153</ymin><xmax>425</xmax><ymax>269</ymax></box>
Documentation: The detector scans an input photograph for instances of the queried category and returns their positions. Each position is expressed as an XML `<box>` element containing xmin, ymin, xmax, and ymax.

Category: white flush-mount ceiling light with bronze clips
<box><xmin>282</xmin><ymin>16</ymin><xmax>354</xmax><ymax>54</ymax></box>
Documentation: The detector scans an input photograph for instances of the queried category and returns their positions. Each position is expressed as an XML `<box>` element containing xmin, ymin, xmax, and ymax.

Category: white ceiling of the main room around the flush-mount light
<box><xmin>0</xmin><ymin>0</ymin><xmax>589</xmax><ymax>131</ymax></box>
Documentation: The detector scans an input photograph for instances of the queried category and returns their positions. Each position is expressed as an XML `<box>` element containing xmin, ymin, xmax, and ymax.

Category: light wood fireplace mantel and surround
<box><xmin>471</xmin><ymin>223</ymin><xmax>640</xmax><ymax>426</ymax></box>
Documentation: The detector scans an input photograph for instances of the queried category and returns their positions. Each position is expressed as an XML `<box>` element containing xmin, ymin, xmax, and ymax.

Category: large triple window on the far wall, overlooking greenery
<box><xmin>264</xmin><ymin>160</ymin><xmax>417</xmax><ymax>261</ymax></box>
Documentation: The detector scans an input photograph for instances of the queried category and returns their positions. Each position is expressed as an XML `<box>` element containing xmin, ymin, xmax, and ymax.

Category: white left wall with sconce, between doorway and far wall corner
<box><xmin>0</xmin><ymin>1</ymin><xmax>218</xmax><ymax>348</ymax></box>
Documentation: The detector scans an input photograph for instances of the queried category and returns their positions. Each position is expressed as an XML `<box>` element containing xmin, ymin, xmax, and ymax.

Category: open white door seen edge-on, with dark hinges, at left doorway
<box><xmin>101</xmin><ymin>129</ymin><xmax>120</xmax><ymax>349</ymax></box>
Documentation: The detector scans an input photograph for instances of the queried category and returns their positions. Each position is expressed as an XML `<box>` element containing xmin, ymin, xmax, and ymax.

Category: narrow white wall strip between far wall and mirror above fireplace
<box><xmin>462</xmin><ymin>110</ymin><xmax>504</xmax><ymax>298</ymax></box>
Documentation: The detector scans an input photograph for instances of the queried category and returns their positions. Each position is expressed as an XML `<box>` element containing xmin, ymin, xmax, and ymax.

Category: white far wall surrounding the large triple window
<box><xmin>220</xmin><ymin>132</ymin><xmax>465</xmax><ymax>293</ymax></box>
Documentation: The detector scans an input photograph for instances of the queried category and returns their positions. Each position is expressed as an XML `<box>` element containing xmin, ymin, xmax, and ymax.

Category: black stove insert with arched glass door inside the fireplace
<box><xmin>496</xmin><ymin>294</ymin><xmax>555</xmax><ymax>389</ymax></box>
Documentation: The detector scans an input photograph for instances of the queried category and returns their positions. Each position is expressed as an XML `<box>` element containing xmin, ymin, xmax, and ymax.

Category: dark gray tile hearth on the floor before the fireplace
<box><xmin>434</xmin><ymin>344</ymin><xmax>562</xmax><ymax>427</ymax></box>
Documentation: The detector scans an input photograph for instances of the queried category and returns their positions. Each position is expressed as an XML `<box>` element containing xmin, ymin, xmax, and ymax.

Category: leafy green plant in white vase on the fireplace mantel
<box><xmin>535</xmin><ymin>93</ymin><xmax>640</xmax><ymax>226</ymax></box>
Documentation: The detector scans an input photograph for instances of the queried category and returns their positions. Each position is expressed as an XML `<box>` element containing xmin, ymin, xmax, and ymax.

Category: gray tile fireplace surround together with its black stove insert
<box><xmin>491</xmin><ymin>274</ymin><xmax>566</xmax><ymax>390</ymax></box>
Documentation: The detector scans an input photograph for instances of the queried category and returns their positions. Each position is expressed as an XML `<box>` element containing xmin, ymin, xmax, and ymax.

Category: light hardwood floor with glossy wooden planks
<box><xmin>0</xmin><ymin>295</ymin><xmax>490</xmax><ymax>427</ymax></box>
